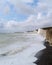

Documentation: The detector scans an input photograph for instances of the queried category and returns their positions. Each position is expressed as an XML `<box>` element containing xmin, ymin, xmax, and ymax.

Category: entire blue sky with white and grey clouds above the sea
<box><xmin>0</xmin><ymin>0</ymin><xmax>52</xmax><ymax>33</ymax></box>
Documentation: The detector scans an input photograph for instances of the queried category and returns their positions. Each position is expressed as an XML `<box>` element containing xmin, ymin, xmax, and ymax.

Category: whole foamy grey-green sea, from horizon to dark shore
<box><xmin>0</xmin><ymin>32</ymin><xmax>45</xmax><ymax>65</ymax></box>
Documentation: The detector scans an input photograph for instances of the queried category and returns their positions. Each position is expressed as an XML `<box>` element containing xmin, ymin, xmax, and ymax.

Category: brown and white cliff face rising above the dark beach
<box><xmin>38</xmin><ymin>27</ymin><xmax>52</xmax><ymax>46</ymax></box>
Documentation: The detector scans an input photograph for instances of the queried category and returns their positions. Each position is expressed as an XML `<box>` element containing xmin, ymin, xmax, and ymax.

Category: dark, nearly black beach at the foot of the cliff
<box><xmin>34</xmin><ymin>42</ymin><xmax>52</xmax><ymax>65</ymax></box>
